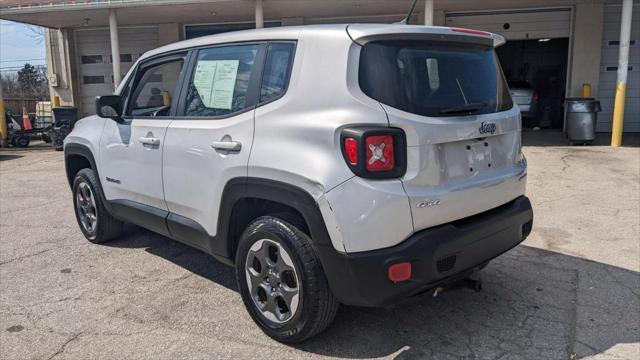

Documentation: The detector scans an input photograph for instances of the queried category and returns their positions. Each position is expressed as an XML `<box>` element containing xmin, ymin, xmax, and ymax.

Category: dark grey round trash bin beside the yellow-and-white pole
<box><xmin>564</xmin><ymin>98</ymin><xmax>601</xmax><ymax>144</ymax></box>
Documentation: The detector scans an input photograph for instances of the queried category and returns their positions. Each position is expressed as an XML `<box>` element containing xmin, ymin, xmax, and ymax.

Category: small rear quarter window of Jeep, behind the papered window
<box><xmin>260</xmin><ymin>43</ymin><xmax>295</xmax><ymax>102</ymax></box>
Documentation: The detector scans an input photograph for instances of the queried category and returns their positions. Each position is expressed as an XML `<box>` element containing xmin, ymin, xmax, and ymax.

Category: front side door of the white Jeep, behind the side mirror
<box><xmin>100</xmin><ymin>54</ymin><xmax>185</xmax><ymax>233</ymax></box>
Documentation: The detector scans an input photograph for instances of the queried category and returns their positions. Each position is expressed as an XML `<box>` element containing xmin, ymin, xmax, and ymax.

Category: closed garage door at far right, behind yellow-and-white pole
<box><xmin>596</xmin><ymin>4</ymin><xmax>640</xmax><ymax>132</ymax></box>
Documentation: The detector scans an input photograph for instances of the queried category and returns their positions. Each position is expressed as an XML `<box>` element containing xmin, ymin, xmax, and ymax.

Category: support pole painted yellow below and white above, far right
<box><xmin>611</xmin><ymin>0</ymin><xmax>633</xmax><ymax>147</ymax></box>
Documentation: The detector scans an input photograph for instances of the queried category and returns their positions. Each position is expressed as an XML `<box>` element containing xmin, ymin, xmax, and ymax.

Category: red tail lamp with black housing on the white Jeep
<box><xmin>340</xmin><ymin>127</ymin><xmax>407</xmax><ymax>179</ymax></box>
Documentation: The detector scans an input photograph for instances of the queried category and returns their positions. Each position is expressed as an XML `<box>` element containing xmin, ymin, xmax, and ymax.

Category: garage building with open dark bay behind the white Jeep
<box><xmin>0</xmin><ymin>0</ymin><xmax>640</xmax><ymax>132</ymax></box>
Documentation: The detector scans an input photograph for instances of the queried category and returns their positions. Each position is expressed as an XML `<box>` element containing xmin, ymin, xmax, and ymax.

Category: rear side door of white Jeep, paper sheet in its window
<box><xmin>163</xmin><ymin>43</ymin><xmax>266</xmax><ymax>250</ymax></box>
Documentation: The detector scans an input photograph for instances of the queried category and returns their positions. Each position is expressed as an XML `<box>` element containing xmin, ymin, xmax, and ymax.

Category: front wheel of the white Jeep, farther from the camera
<box><xmin>73</xmin><ymin>169</ymin><xmax>124</xmax><ymax>244</ymax></box>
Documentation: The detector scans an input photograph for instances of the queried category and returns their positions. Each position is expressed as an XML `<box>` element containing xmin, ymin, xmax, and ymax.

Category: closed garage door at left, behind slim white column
<box><xmin>76</xmin><ymin>26</ymin><xmax>158</xmax><ymax>116</ymax></box>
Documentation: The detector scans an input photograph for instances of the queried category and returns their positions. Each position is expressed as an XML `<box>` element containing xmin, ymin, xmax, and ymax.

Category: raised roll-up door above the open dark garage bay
<box><xmin>445</xmin><ymin>9</ymin><xmax>571</xmax><ymax>40</ymax></box>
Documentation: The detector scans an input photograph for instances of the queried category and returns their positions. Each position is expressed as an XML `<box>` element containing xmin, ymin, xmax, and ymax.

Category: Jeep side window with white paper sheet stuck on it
<box><xmin>184</xmin><ymin>45</ymin><xmax>259</xmax><ymax>117</ymax></box>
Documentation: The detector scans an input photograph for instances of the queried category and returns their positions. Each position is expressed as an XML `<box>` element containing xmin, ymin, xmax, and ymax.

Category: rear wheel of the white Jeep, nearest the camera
<box><xmin>236</xmin><ymin>216</ymin><xmax>339</xmax><ymax>343</ymax></box>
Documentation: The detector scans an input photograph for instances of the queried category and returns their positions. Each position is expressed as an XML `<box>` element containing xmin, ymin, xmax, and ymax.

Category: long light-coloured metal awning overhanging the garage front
<box><xmin>0</xmin><ymin>0</ymin><xmax>584</xmax><ymax>28</ymax></box>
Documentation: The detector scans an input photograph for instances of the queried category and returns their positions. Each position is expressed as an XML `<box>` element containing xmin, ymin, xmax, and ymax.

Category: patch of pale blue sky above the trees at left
<box><xmin>0</xmin><ymin>20</ymin><xmax>46</xmax><ymax>72</ymax></box>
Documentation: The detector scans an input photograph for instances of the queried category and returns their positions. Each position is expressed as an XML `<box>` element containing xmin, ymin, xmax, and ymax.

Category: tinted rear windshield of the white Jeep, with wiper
<box><xmin>359</xmin><ymin>40</ymin><xmax>513</xmax><ymax>117</ymax></box>
